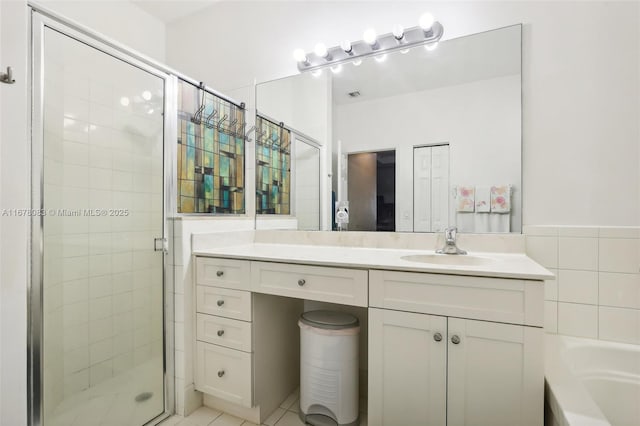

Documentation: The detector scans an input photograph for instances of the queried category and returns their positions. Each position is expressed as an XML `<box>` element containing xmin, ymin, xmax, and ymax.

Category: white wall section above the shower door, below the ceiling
<box><xmin>36</xmin><ymin>0</ymin><xmax>166</xmax><ymax>62</ymax></box>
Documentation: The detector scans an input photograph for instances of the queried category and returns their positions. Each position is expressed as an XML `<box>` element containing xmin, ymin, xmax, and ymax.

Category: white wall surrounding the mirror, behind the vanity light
<box><xmin>167</xmin><ymin>1</ymin><xmax>640</xmax><ymax>225</ymax></box>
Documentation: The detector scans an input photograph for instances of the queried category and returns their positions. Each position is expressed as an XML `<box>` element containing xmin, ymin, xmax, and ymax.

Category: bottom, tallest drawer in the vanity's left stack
<box><xmin>195</xmin><ymin>342</ymin><xmax>252</xmax><ymax>407</ymax></box>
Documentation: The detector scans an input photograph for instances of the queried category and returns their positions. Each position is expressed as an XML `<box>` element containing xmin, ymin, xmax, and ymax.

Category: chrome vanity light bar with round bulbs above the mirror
<box><xmin>298</xmin><ymin>21</ymin><xmax>444</xmax><ymax>72</ymax></box>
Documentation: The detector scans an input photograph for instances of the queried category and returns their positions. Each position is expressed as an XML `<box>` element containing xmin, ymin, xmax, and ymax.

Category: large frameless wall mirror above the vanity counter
<box><xmin>256</xmin><ymin>25</ymin><xmax>522</xmax><ymax>233</ymax></box>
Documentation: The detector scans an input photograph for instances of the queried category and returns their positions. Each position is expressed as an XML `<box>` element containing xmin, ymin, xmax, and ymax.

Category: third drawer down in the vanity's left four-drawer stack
<box><xmin>196</xmin><ymin>314</ymin><xmax>251</xmax><ymax>352</ymax></box>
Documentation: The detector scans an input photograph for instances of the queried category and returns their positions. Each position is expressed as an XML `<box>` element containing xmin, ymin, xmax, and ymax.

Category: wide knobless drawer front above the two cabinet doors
<box><xmin>369</xmin><ymin>271</ymin><xmax>544</xmax><ymax>327</ymax></box>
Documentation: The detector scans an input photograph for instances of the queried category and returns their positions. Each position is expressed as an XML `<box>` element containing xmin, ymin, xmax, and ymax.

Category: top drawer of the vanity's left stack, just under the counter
<box><xmin>196</xmin><ymin>257</ymin><xmax>251</xmax><ymax>290</ymax></box>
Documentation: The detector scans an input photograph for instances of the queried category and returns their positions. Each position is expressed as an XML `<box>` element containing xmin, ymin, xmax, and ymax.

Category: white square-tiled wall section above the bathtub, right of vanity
<box><xmin>524</xmin><ymin>226</ymin><xmax>640</xmax><ymax>344</ymax></box>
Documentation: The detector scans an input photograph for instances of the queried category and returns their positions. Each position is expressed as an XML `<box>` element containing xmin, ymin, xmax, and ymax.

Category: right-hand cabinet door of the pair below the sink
<box><xmin>447</xmin><ymin>318</ymin><xmax>544</xmax><ymax>426</ymax></box>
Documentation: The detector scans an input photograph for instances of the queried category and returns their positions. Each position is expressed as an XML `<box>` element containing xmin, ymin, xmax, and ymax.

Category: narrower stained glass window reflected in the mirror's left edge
<box><xmin>256</xmin><ymin>115</ymin><xmax>291</xmax><ymax>214</ymax></box>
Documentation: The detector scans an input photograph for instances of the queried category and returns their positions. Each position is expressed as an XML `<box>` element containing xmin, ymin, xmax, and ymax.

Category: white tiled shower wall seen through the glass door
<box><xmin>44</xmin><ymin>40</ymin><xmax>162</xmax><ymax>413</ymax></box>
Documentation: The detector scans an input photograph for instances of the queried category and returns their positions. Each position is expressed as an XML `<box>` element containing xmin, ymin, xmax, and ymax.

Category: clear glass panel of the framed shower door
<box><xmin>36</xmin><ymin>25</ymin><xmax>165</xmax><ymax>426</ymax></box>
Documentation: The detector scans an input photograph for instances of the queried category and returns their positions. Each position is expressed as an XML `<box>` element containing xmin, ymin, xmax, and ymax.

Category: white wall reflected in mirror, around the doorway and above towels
<box><xmin>333</xmin><ymin>76</ymin><xmax>521</xmax><ymax>231</ymax></box>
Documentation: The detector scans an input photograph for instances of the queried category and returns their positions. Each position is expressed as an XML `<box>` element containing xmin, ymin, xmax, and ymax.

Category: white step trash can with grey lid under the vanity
<box><xmin>298</xmin><ymin>310</ymin><xmax>360</xmax><ymax>426</ymax></box>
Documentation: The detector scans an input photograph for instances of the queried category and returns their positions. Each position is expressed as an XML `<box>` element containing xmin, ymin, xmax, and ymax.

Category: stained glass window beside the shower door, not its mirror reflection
<box><xmin>177</xmin><ymin>80</ymin><xmax>245</xmax><ymax>214</ymax></box>
